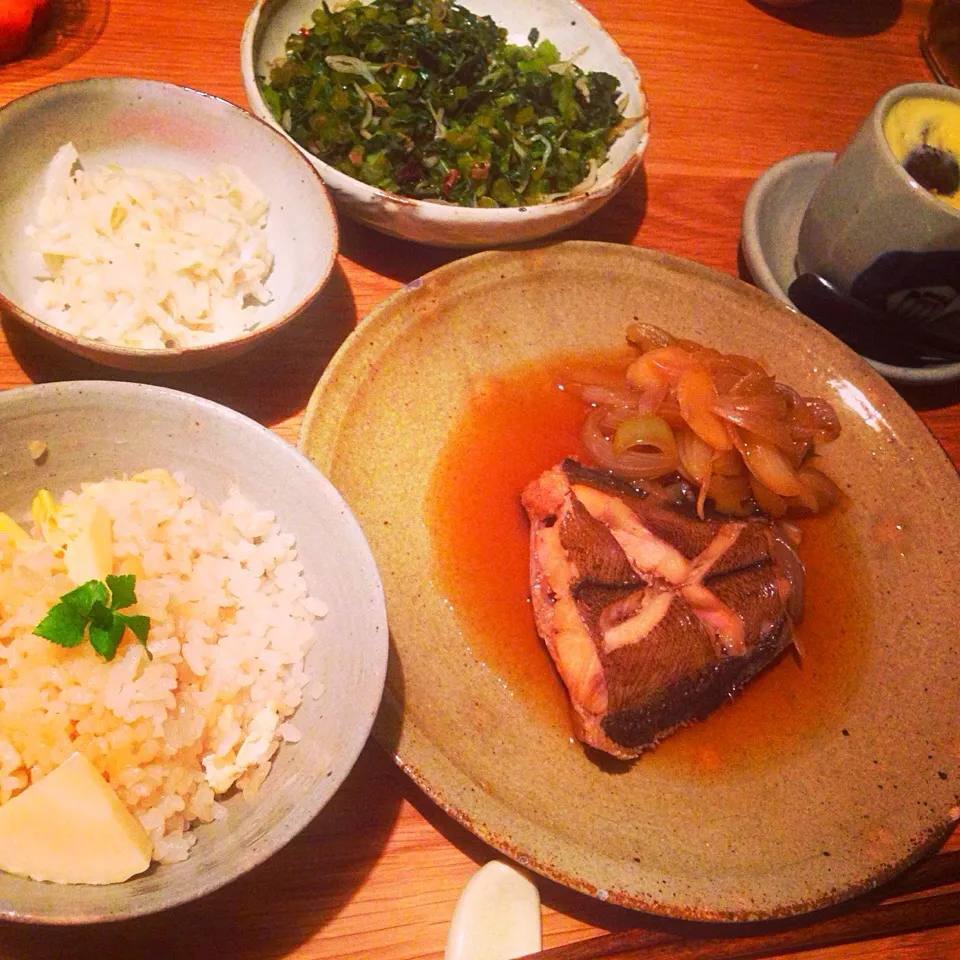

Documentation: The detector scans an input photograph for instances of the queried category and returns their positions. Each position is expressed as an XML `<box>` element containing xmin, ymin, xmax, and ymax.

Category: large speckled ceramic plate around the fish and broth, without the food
<box><xmin>301</xmin><ymin>242</ymin><xmax>960</xmax><ymax>920</ymax></box>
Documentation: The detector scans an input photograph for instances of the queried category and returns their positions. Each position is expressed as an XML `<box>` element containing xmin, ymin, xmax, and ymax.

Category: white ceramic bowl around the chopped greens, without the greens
<box><xmin>240</xmin><ymin>0</ymin><xmax>648</xmax><ymax>247</ymax></box>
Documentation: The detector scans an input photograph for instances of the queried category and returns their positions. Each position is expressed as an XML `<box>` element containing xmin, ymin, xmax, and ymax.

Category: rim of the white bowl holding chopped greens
<box><xmin>240</xmin><ymin>0</ymin><xmax>650</xmax><ymax>221</ymax></box>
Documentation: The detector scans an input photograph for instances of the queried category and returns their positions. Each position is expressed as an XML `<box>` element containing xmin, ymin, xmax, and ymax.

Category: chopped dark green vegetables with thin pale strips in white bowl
<box><xmin>259</xmin><ymin>0</ymin><xmax>635</xmax><ymax>207</ymax></box>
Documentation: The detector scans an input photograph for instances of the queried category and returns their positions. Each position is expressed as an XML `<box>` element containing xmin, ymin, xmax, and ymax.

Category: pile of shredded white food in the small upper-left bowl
<box><xmin>26</xmin><ymin>143</ymin><xmax>273</xmax><ymax>349</ymax></box>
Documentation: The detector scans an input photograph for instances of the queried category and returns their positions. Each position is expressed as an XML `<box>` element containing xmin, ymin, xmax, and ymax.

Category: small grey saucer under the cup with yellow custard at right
<box><xmin>740</xmin><ymin>152</ymin><xmax>960</xmax><ymax>384</ymax></box>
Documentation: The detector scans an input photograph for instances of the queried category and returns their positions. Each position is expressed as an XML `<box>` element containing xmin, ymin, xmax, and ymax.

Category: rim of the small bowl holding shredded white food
<box><xmin>0</xmin><ymin>75</ymin><xmax>340</xmax><ymax>361</ymax></box>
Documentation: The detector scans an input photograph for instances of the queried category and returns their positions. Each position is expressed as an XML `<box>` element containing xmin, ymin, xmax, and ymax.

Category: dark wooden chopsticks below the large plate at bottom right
<box><xmin>530</xmin><ymin>851</ymin><xmax>960</xmax><ymax>960</ymax></box>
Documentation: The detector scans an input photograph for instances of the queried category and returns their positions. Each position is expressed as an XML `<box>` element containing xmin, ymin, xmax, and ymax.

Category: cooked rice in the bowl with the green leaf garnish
<box><xmin>0</xmin><ymin>471</ymin><xmax>326</xmax><ymax>862</ymax></box>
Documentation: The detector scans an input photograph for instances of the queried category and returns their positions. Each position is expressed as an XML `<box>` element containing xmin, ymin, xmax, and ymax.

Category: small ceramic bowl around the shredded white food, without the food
<box><xmin>0</xmin><ymin>77</ymin><xmax>338</xmax><ymax>371</ymax></box>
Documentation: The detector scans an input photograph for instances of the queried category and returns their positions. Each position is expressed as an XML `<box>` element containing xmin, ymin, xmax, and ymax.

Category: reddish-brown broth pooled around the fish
<box><xmin>428</xmin><ymin>358</ymin><xmax>872</xmax><ymax>775</ymax></box>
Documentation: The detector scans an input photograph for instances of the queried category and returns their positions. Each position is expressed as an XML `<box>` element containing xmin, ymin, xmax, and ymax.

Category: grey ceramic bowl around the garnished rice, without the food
<box><xmin>0</xmin><ymin>381</ymin><xmax>387</xmax><ymax>924</ymax></box>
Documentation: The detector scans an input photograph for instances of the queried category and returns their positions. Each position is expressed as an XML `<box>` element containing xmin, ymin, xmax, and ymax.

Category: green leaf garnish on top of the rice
<box><xmin>33</xmin><ymin>573</ymin><xmax>153</xmax><ymax>660</ymax></box>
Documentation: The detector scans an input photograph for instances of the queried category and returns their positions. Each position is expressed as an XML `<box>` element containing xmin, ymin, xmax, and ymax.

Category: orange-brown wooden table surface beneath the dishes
<box><xmin>0</xmin><ymin>0</ymin><xmax>960</xmax><ymax>960</ymax></box>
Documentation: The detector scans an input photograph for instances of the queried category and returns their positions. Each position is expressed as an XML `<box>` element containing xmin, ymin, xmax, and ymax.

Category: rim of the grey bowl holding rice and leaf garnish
<box><xmin>0</xmin><ymin>380</ymin><xmax>389</xmax><ymax>926</ymax></box>
